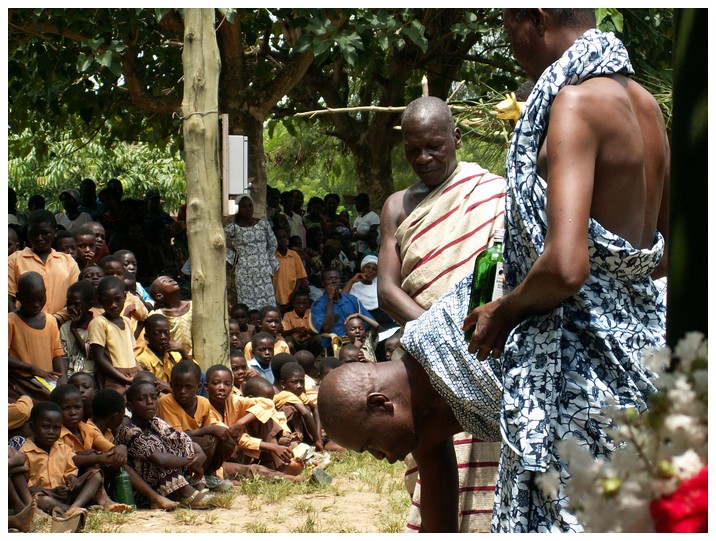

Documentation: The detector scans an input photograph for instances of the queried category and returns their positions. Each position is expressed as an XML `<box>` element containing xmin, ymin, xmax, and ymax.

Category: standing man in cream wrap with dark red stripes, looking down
<box><xmin>378</xmin><ymin>97</ymin><xmax>505</xmax><ymax>532</ymax></box>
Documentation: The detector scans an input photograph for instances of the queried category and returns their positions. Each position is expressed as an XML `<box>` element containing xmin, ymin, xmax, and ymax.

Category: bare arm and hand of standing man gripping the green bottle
<box><xmin>463</xmin><ymin>89</ymin><xmax>600</xmax><ymax>360</ymax></box>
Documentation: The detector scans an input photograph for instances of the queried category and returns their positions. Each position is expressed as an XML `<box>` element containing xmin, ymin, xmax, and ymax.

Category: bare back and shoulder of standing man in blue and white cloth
<box><xmin>538</xmin><ymin>75</ymin><xmax>669</xmax><ymax>249</ymax></box>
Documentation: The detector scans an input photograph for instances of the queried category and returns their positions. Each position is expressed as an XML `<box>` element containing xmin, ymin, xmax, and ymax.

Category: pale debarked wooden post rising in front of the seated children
<box><xmin>182</xmin><ymin>9</ymin><xmax>229</xmax><ymax>371</ymax></box>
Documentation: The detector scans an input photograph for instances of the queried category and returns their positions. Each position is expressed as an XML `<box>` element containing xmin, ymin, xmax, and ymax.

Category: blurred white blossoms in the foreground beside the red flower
<box><xmin>564</xmin><ymin>333</ymin><xmax>708</xmax><ymax>532</ymax></box>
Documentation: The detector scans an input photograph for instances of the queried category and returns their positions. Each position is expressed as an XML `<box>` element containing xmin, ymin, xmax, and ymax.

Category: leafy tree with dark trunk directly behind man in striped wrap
<box><xmin>277</xmin><ymin>8</ymin><xmax>514</xmax><ymax>208</ymax></box>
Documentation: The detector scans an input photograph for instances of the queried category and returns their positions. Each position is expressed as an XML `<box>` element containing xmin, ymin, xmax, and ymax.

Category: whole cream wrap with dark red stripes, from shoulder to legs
<box><xmin>395</xmin><ymin>162</ymin><xmax>505</xmax><ymax>532</ymax></box>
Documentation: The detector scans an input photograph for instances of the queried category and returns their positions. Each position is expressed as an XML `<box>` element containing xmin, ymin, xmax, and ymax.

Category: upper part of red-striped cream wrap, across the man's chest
<box><xmin>395</xmin><ymin>162</ymin><xmax>505</xmax><ymax>310</ymax></box>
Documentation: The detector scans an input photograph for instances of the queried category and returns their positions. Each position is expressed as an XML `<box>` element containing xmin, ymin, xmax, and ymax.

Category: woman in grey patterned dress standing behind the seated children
<box><xmin>224</xmin><ymin>195</ymin><xmax>279</xmax><ymax>310</ymax></box>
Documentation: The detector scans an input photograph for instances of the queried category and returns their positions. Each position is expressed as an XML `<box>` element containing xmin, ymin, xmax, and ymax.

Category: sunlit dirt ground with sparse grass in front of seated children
<box><xmin>98</xmin><ymin>458</ymin><xmax>409</xmax><ymax>534</ymax></box>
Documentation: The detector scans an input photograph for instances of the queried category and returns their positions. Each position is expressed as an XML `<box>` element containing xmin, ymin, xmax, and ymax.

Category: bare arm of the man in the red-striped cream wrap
<box><xmin>378</xmin><ymin>191</ymin><xmax>425</xmax><ymax>325</ymax></box>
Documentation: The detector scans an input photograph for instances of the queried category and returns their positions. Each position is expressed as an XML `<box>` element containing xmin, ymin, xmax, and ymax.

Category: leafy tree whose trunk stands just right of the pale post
<box><xmin>8</xmin><ymin>8</ymin><xmax>346</xmax><ymax>215</ymax></box>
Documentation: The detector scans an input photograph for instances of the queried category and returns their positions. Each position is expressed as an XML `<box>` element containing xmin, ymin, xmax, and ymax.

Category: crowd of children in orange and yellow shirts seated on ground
<box><xmin>8</xmin><ymin>182</ymin><xmax>399</xmax><ymax>531</ymax></box>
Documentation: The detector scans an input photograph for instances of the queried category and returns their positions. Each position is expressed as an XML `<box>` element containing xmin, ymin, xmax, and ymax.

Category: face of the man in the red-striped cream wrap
<box><xmin>403</xmin><ymin>115</ymin><xmax>460</xmax><ymax>188</ymax></box>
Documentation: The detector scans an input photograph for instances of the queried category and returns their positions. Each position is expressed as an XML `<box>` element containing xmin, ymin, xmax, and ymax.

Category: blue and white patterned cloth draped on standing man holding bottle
<box><xmin>492</xmin><ymin>30</ymin><xmax>666</xmax><ymax>532</ymax></box>
